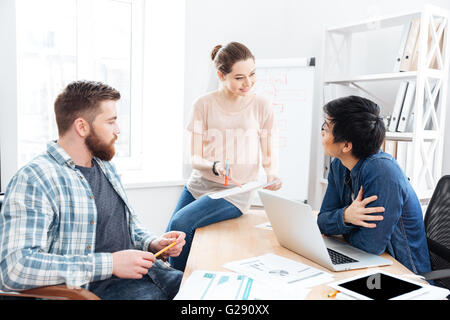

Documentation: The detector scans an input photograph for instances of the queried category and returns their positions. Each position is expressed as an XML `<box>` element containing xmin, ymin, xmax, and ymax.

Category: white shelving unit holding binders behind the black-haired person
<box><xmin>318</xmin><ymin>5</ymin><xmax>449</xmax><ymax>200</ymax></box>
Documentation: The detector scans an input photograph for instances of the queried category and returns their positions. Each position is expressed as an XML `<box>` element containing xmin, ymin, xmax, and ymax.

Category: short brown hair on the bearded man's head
<box><xmin>55</xmin><ymin>80</ymin><xmax>120</xmax><ymax>136</ymax></box>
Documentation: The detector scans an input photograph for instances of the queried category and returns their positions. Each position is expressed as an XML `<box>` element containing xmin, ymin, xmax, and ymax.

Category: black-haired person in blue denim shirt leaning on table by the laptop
<box><xmin>317</xmin><ymin>96</ymin><xmax>431</xmax><ymax>273</ymax></box>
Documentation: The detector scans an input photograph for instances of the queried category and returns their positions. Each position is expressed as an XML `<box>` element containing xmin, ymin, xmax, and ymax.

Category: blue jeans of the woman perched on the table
<box><xmin>166</xmin><ymin>187</ymin><xmax>242</xmax><ymax>271</ymax></box>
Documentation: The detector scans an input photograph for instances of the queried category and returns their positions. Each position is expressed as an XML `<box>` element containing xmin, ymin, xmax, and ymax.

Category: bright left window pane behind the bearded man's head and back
<box><xmin>16</xmin><ymin>0</ymin><xmax>77</xmax><ymax>167</ymax></box>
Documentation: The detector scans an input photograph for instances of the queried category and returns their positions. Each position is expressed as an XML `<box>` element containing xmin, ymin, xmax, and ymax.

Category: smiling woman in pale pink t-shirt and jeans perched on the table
<box><xmin>167</xmin><ymin>42</ymin><xmax>281</xmax><ymax>271</ymax></box>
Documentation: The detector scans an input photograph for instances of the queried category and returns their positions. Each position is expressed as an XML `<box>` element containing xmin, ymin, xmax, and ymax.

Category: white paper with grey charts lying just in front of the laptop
<box><xmin>224</xmin><ymin>253</ymin><xmax>333</xmax><ymax>292</ymax></box>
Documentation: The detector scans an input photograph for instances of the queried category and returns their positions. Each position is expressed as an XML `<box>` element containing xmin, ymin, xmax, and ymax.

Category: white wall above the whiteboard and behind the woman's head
<box><xmin>185</xmin><ymin>0</ymin><xmax>450</xmax><ymax>209</ymax></box>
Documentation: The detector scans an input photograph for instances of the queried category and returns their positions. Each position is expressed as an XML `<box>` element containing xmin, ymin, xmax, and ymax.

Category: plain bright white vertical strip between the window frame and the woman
<box><xmin>139</xmin><ymin>0</ymin><xmax>185</xmax><ymax>181</ymax></box>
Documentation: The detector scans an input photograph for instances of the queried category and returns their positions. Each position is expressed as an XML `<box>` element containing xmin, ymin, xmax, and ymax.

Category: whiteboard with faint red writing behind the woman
<box><xmin>253</xmin><ymin>58</ymin><xmax>315</xmax><ymax>205</ymax></box>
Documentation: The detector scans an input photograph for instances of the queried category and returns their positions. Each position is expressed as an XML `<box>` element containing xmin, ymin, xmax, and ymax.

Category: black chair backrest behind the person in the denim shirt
<box><xmin>424</xmin><ymin>175</ymin><xmax>450</xmax><ymax>289</ymax></box>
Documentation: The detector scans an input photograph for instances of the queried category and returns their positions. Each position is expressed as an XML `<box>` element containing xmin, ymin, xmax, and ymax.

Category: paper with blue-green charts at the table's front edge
<box><xmin>175</xmin><ymin>270</ymin><xmax>289</xmax><ymax>300</ymax></box>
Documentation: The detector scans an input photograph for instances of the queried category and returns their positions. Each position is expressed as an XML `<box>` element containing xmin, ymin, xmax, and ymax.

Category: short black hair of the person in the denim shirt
<box><xmin>323</xmin><ymin>96</ymin><xmax>386</xmax><ymax>159</ymax></box>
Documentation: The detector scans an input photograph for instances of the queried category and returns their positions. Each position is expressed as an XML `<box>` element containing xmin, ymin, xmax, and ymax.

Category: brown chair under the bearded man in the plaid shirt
<box><xmin>0</xmin><ymin>193</ymin><xmax>100</xmax><ymax>300</ymax></box>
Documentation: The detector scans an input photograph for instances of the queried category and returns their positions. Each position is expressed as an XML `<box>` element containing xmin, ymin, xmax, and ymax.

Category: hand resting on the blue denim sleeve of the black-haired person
<box><xmin>344</xmin><ymin>186</ymin><xmax>384</xmax><ymax>228</ymax></box>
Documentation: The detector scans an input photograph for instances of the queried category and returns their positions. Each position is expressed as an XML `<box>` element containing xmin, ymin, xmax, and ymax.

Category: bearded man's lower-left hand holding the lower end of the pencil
<box><xmin>112</xmin><ymin>250</ymin><xmax>155</xmax><ymax>279</ymax></box>
